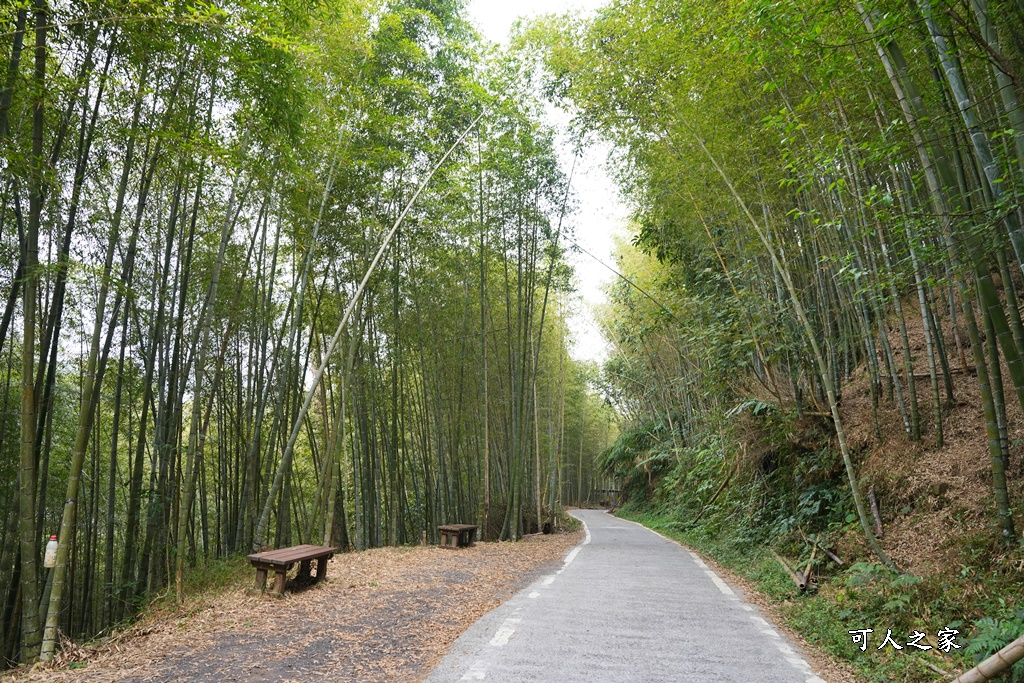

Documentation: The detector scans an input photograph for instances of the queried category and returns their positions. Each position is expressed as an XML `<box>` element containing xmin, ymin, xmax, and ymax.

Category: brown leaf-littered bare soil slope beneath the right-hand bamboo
<box><xmin>842</xmin><ymin>316</ymin><xmax>1024</xmax><ymax>575</ymax></box>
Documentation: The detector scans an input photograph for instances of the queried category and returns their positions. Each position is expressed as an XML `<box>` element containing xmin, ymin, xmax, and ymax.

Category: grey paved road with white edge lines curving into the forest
<box><xmin>427</xmin><ymin>510</ymin><xmax>824</xmax><ymax>683</ymax></box>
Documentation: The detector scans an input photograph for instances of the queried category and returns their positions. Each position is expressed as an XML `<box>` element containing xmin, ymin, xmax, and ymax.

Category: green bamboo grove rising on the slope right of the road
<box><xmin>536</xmin><ymin>0</ymin><xmax>1024</xmax><ymax>564</ymax></box>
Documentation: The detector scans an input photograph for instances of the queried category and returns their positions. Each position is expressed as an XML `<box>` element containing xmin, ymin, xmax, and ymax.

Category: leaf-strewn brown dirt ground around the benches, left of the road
<box><xmin>3</xmin><ymin>531</ymin><xmax>582</xmax><ymax>683</ymax></box>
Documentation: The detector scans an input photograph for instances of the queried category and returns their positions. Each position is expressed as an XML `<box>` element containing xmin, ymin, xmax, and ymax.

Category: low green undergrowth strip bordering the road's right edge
<box><xmin>618</xmin><ymin>502</ymin><xmax>1024</xmax><ymax>683</ymax></box>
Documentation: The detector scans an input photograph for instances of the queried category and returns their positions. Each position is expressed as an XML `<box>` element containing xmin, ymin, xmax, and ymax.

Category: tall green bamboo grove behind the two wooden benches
<box><xmin>0</xmin><ymin>0</ymin><xmax>614</xmax><ymax>665</ymax></box>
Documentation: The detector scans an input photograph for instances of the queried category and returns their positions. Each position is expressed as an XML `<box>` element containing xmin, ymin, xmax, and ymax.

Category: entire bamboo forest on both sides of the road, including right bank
<box><xmin>0</xmin><ymin>0</ymin><xmax>1024</xmax><ymax>681</ymax></box>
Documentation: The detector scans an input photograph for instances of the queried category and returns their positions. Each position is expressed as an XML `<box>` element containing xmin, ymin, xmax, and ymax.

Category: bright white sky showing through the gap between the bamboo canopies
<box><xmin>469</xmin><ymin>0</ymin><xmax>628</xmax><ymax>360</ymax></box>
